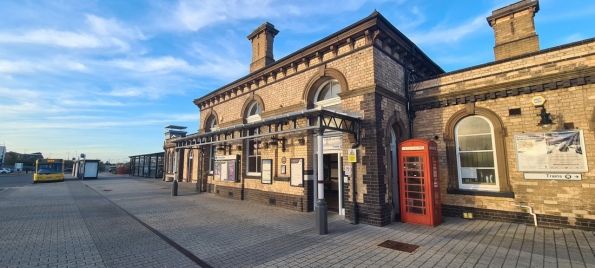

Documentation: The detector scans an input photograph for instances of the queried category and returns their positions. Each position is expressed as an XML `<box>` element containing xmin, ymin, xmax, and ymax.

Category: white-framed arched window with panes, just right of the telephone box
<box><xmin>455</xmin><ymin>115</ymin><xmax>500</xmax><ymax>191</ymax></box>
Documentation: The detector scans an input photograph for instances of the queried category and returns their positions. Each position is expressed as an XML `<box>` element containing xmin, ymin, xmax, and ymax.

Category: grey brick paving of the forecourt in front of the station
<box><xmin>0</xmin><ymin>176</ymin><xmax>595</xmax><ymax>267</ymax></box>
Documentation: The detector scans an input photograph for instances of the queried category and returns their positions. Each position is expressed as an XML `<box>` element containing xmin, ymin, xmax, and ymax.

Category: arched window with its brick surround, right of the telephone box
<box><xmin>444</xmin><ymin>106</ymin><xmax>514</xmax><ymax>198</ymax></box>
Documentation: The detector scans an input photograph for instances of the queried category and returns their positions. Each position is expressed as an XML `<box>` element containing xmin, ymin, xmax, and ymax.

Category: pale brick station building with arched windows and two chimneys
<box><xmin>164</xmin><ymin>0</ymin><xmax>595</xmax><ymax>230</ymax></box>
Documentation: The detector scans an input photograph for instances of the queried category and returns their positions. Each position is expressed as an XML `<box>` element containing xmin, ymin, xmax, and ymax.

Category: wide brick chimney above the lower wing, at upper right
<box><xmin>487</xmin><ymin>0</ymin><xmax>539</xmax><ymax>60</ymax></box>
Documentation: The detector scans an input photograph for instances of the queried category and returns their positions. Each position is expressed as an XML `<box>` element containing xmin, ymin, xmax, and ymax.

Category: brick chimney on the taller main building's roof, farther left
<box><xmin>248</xmin><ymin>22</ymin><xmax>279</xmax><ymax>73</ymax></box>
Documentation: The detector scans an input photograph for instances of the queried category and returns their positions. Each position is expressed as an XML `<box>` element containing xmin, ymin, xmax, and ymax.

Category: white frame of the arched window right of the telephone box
<box><xmin>454</xmin><ymin>115</ymin><xmax>500</xmax><ymax>192</ymax></box>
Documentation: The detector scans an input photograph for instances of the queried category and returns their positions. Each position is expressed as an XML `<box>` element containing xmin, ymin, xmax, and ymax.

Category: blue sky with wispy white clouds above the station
<box><xmin>0</xmin><ymin>0</ymin><xmax>595</xmax><ymax>162</ymax></box>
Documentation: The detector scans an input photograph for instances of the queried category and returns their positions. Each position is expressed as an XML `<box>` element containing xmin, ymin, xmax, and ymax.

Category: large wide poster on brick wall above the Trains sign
<box><xmin>514</xmin><ymin>130</ymin><xmax>589</xmax><ymax>172</ymax></box>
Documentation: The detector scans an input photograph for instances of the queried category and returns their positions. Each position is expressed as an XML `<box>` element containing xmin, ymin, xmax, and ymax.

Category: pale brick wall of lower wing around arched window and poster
<box><xmin>414</xmin><ymin>40</ymin><xmax>595</xmax><ymax>228</ymax></box>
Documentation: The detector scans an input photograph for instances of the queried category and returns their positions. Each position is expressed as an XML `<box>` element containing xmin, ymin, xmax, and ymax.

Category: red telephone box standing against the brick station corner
<box><xmin>398</xmin><ymin>139</ymin><xmax>442</xmax><ymax>226</ymax></box>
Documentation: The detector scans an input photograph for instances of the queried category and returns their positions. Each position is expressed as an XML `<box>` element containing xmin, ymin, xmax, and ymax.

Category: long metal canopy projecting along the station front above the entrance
<box><xmin>175</xmin><ymin>108</ymin><xmax>361</xmax><ymax>149</ymax></box>
